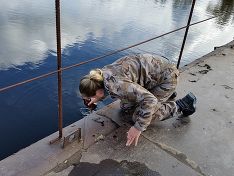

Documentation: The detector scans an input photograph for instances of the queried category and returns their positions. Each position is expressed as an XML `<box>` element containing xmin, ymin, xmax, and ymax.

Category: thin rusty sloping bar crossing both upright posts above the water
<box><xmin>0</xmin><ymin>16</ymin><xmax>217</xmax><ymax>92</ymax></box>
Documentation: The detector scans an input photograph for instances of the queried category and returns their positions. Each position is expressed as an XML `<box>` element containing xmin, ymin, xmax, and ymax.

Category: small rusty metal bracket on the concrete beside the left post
<box><xmin>62</xmin><ymin>128</ymin><xmax>81</xmax><ymax>148</ymax></box>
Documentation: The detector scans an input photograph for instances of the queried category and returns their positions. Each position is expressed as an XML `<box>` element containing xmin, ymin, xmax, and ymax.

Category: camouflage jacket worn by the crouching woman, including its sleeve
<box><xmin>102</xmin><ymin>54</ymin><xmax>175</xmax><ymax>131</ymax></box>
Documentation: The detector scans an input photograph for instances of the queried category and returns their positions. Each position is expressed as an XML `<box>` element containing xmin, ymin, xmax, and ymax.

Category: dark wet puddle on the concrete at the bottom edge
<box><xmin>69</xmin><ymin>159</ymin><xmax>161</xmax><ymax>176</ymax></box>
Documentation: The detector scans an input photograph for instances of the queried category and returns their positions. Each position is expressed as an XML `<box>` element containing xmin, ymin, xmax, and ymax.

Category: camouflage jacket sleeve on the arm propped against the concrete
<box><xmin>108</xmin><ymin>79</ymin><xmax>158</xmax><ymax>131</ymax></box>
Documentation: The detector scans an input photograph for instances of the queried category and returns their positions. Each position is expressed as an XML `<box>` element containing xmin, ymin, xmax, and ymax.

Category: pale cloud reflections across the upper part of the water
<box><xmin>0</xmin><ymin>0</ymin><xmax>234</xmax><ymax>69</ymax></box>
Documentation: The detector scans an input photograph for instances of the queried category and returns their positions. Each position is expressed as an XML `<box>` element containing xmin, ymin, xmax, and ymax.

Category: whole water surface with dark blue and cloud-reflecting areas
<box><xmin>0</xmin><ymin>0</ymin><xmax>234</xmax><ymax>159</ymax></box>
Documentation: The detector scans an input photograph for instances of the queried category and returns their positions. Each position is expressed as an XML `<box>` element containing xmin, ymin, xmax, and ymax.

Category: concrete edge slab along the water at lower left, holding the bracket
<box><xmin>0</xmin><ymin>113</ymin><xmax>116</xmax><ymax>176</ymax></box>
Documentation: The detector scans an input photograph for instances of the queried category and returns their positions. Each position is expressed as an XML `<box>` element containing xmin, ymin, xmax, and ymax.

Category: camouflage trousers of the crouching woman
<box><xmin>120</xmin><ymin>67</ymin><xmax>179</xmax><ymax>122</ymax></box>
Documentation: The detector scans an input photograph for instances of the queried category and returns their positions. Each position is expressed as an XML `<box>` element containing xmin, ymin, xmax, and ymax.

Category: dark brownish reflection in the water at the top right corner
<box><xmin>207</xmin><ymin>0</ymin><xmax>234</xmax><ymax>25</ymax></box>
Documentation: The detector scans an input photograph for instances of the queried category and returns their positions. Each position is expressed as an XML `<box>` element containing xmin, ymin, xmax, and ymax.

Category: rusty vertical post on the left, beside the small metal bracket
<box><xmin>55</xmin><ymin>0</ymin><xmax>63</xmax><ymax>138</ymax></box>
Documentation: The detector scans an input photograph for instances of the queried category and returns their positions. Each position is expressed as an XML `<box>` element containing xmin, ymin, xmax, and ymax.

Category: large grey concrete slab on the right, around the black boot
<box><xmin>142</xmin><ymin>44</ymin><xmax>234</xmax><ymax>176</ymax></box>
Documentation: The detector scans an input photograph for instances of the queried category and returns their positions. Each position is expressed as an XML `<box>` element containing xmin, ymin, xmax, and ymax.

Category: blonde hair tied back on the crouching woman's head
<box><xmin>79</xmin><ymin>69</ymin><xmax>104</xmax><ymax>97</ymax></box>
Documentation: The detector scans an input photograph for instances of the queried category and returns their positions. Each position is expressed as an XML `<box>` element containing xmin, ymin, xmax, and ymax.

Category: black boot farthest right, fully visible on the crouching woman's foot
<box><xmin>176</xmin><ymin>92</ymin><xmax>197</xmax><ymax>116</ymax></box>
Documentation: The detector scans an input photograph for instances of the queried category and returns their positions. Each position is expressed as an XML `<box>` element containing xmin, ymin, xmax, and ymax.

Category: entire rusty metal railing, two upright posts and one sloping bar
<box><xmin>0</xmin><ymin>0</ymin><xmax>216</xmax><ymax>143</ymax></box>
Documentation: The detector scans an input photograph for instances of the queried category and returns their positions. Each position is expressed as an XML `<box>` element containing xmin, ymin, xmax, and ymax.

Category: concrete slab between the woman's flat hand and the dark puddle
<box><xmin>68</xmin><ymin>127</ymin><xmax>200</xmax><ymax>176</ymax></box>
